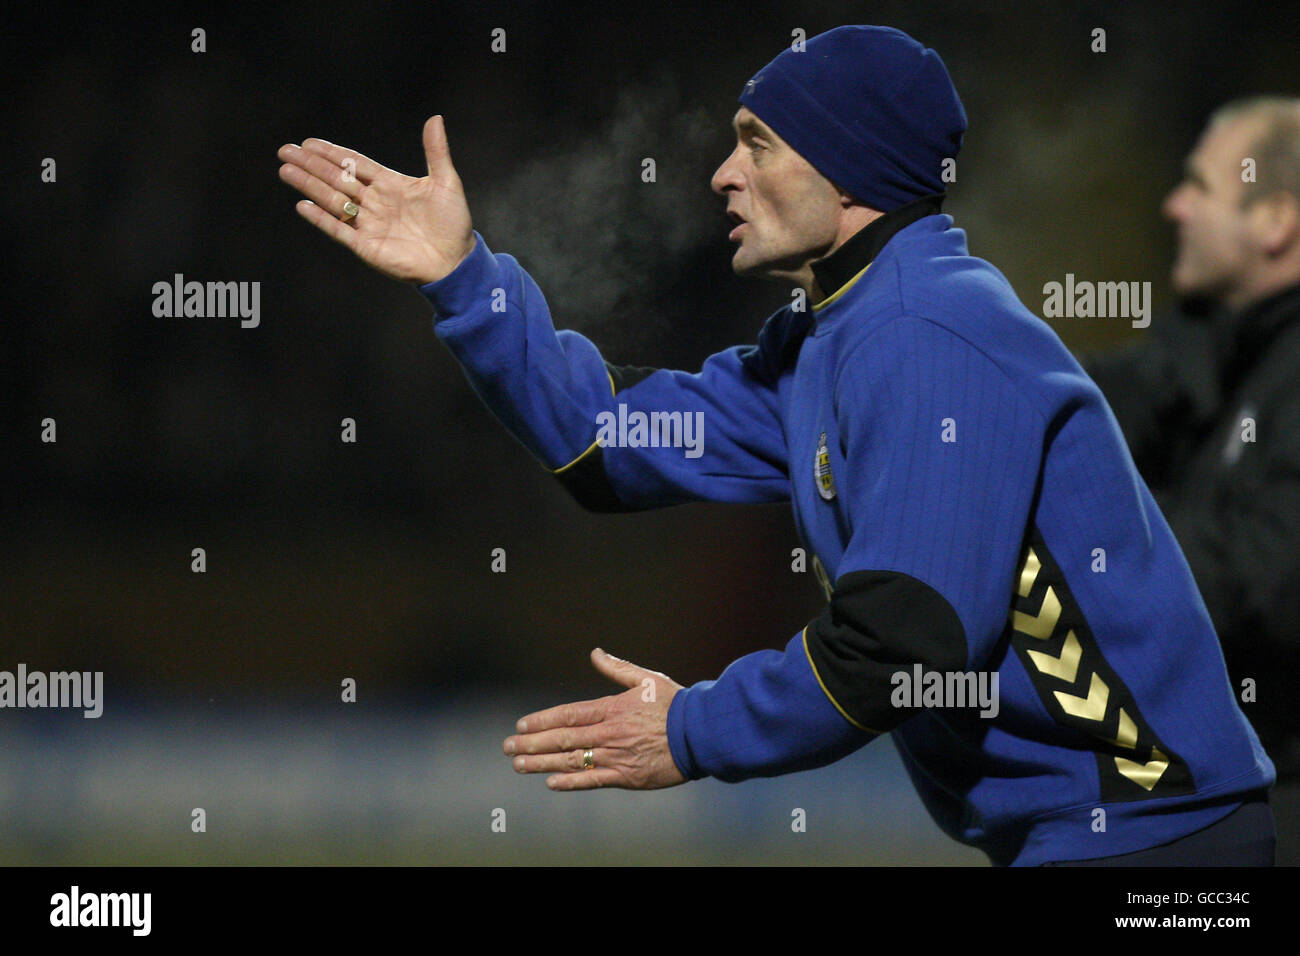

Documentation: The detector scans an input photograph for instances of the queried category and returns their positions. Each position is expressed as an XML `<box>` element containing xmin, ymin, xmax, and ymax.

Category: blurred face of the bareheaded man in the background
<box><xmin>1164</xmin><ymin>120</ymin><xmax>1256</xmax><ymax>304</ymax></box>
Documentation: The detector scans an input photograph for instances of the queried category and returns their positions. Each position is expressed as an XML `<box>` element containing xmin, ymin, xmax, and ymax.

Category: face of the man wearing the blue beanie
<box><xmin>711</xmin><ymin>107</ymin><xmax>841</xmax><ymax>278</ymax></box>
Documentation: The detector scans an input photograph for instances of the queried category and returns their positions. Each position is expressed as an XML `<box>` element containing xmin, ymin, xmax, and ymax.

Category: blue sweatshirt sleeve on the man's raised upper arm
<box><xmin>420</xmin><ymin>232</ymin><xmax>789</xmax><ymax>510</ymax></box>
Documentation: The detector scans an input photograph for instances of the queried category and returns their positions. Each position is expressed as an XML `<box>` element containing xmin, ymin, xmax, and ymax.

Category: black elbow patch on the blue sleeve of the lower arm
<box><xmin>805</xmin><ymin>571</ymin><xmax>967</xmax><ymax>734</ymax></box>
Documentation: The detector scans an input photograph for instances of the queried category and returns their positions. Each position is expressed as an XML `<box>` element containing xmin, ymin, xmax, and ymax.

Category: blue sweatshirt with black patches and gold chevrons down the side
<box><xmin>421</xmin><ymin>209</ymin><xmax>1274</xmax><ymax>865</ymax></box>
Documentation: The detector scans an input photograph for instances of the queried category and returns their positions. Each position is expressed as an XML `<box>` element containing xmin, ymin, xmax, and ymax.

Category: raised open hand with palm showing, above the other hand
<box><xmin>277</xmin><ymin>116</ymin><xmax>475</xmax><ymax>285</ymax></box>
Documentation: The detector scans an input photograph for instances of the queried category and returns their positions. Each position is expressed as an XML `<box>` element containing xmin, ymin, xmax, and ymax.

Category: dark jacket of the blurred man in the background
<box><xmin>1080</xmin><ymin>285</ymin><xmax>1300</xmax><ymax>778</ymax></box>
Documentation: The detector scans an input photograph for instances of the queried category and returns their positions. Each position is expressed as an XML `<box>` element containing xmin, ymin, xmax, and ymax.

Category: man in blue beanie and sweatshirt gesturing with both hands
<box><xmin>280</xmin><ymin>26</ymin><xmax>1274</xmax><ymax>866</ymax></box>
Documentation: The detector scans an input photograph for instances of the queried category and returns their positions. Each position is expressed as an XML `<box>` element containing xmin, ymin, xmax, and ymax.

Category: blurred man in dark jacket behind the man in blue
<box><xmin>1083</xmin><ymin>98</ymin><xmax>1300</xmax><ymax>865</ymax></box>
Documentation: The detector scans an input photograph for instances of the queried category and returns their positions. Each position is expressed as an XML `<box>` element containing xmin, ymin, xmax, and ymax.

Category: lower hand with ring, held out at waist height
<box><xmin>504</xmin><ymin>648</ymin><xmax>686</xmax><ymax>790</ymax></box>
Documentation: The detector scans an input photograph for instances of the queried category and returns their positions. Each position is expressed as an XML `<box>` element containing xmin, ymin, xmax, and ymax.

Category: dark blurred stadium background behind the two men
<box><xmin>0</xmin><ymin>1</ymin><xmax>1300</xmax><ymax>862</ymax></box>
